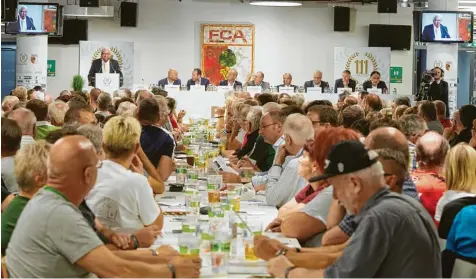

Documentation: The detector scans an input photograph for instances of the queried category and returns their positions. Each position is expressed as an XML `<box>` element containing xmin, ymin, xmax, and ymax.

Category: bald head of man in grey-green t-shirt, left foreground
<box><xmin>48</xmin><ymin>135</ymin><xmax>98</xmax><ymax>204</ymax></box>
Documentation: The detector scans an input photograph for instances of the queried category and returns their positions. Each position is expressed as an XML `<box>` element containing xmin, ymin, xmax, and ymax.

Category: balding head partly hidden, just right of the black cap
<box><xmin>364</xmin><ymin>127</ymin><xmax>410</xmax><ymax>168</ymax></box>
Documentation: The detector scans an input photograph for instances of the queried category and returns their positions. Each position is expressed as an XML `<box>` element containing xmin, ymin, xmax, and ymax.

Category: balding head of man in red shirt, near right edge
<box><xmin>415</xmin><ymin>132</ymin><xmax>450</xmax><ymax>167</ymax></box>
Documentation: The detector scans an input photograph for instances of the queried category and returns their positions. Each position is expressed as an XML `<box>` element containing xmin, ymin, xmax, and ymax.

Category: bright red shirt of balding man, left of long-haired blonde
<box><xmin>411</xmin><ymin>169</ymin><xmax>446</xmax><ymax>221</ymax></box>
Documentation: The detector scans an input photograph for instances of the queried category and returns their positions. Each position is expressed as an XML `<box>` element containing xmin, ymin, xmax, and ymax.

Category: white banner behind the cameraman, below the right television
<box><xmin>426</xmin><ymin>44</ymin><xmax>458</xmax><ymax>115</ymax></box>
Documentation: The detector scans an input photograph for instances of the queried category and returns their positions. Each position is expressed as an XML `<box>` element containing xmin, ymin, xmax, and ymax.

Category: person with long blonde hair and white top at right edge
<box><xmin>435</xmin><ymin>144</ymin><xmax>476</xmax><ymax>222</ymax></box>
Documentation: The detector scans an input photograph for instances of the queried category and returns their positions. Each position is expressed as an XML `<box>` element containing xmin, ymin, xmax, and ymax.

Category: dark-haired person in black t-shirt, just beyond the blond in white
<box><xmin>137</xmin><ymin>98</ymin><xmax>175</xmax><ymax>181</ymax></box>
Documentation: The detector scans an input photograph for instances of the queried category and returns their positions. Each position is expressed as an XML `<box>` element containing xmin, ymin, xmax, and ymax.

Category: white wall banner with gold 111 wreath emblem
<box><xmin>334</xmin><ymin>47</ymin><xmax>390</xmax><ymax>86</ymax></box>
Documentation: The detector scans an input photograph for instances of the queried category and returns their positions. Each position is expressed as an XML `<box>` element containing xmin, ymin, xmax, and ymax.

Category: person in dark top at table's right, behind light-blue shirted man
<box><xmin>234</xmin><ymin>107</ymin><xmax>275</xmax><ymax>172</ymax></box>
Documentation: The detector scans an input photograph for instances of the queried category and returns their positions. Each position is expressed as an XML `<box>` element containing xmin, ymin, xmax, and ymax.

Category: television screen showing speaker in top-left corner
<box><xmin>5</xmin><ymin>2</ymin><xmax>59</xmax><ymax>35</ymax></box>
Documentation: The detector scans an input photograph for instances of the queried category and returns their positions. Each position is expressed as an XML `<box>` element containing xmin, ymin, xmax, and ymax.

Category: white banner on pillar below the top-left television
<box><xmin>16</xmin><ymin>36</ymin><xmax>48</xmax><ymax>89</ymax></box>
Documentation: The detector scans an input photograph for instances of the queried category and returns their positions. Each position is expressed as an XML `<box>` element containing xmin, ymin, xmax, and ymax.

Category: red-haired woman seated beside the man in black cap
<box><xmin>278</xmin><ymin>127</ymin><xmax>360</xmax><ymax>219</ymax></box>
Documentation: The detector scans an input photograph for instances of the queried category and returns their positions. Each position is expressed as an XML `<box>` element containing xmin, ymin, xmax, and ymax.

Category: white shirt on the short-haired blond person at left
<box><xmin>86</xmin><ymin>160</ymin><xmax>160</xmax><ymax>229</ymax></box>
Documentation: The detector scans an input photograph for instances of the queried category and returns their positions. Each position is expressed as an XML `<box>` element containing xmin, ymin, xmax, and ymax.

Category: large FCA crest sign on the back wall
<box><xmin>201</xmin><ymin>24</ymin><xmax>255</xmax><ymax>85</ymax></box>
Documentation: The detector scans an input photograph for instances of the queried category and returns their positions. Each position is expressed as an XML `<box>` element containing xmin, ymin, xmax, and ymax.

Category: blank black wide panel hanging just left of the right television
<box><xmin>369</xmin><ymin>24</ymin><xmax>412</xmax><ymax>50</ymax></box>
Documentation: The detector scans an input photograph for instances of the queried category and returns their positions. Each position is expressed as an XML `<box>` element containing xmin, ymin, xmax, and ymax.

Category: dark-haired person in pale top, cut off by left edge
<box><xmin>2</xmin><ymin>118</ymin><xmax>22</xmax><ymax>193</ymax></box>
